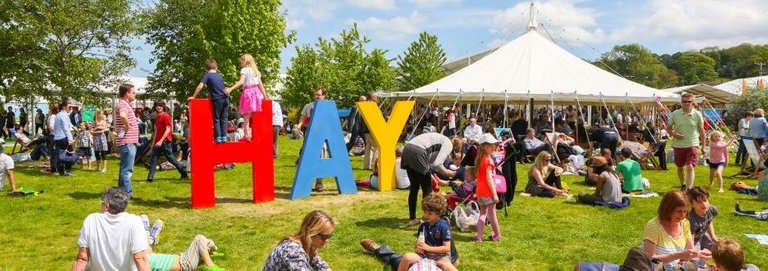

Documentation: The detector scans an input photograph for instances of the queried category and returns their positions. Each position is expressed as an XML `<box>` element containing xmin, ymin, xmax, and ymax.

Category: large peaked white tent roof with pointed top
<box><xmin>385</xmin><ymin>9</ymin><xmax>679</xmax><ymax>104</ymax></box>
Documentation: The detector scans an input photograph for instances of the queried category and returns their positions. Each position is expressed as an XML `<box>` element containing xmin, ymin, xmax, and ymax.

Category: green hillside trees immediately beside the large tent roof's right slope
<box><xmin>597</xmin><ymin>44</ymin><xmax>677</xmax><ymax>88</ymax></box>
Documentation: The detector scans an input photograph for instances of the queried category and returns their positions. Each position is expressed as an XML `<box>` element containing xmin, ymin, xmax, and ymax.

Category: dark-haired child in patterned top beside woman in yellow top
<box><xmin>685</xmin><ymin>186</ymin><xmax>718</xmax><ymax>250</ymax></box>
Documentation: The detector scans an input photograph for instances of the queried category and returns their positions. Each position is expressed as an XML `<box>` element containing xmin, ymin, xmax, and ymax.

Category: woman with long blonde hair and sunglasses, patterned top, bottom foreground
<box><xmin>263</xmin><ymin>210</ymin><xmax>336</xmax><ymax>271</ymax></box>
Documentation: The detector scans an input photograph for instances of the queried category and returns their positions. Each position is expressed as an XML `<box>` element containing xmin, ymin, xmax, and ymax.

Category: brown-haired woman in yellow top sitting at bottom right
<box><xmin>643</xmin><ymin>191</ymin><xmax>711</xmax><ymax>270</ymax></box>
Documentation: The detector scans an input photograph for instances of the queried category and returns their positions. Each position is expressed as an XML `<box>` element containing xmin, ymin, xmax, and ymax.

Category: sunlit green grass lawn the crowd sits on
<box><xmin>0</xmin><ymin>137</ymin><xmax>768</xmax><ymax>270</ymax></box>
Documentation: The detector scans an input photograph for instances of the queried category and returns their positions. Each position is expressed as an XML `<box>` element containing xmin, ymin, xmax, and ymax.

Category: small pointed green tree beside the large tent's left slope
<box><xmin>397</xmin><ymin>32</ymin><xmax>447</xmax><ymax>91</ymax></box>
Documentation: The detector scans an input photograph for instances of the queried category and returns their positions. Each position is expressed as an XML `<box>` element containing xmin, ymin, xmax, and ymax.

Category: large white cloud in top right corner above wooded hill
<box><xmin>610</xmin><ymin>0</ymin><xmax>768</xmax><ymax>49</ymax></box>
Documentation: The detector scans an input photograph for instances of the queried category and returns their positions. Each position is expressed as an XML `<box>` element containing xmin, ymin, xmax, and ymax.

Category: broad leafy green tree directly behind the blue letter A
<box><xmin>281</xmin><ymin>25</ymin><xmax>396</xmax><ymax>107</ymax></box>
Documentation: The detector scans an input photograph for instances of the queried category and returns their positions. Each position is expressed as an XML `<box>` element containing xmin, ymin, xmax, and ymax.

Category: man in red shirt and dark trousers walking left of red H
<box><xmin>147</xmin><ymin>101</ymin><xmax>188</xmax><ymax>183</ymax></box>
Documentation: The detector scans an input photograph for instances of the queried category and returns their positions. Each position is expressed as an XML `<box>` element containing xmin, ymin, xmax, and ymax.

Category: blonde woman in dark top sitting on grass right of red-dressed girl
<box><xmin>525</xmin><ymin>151</ymin><xmax>565</xmax><ymax>198</ymax></box>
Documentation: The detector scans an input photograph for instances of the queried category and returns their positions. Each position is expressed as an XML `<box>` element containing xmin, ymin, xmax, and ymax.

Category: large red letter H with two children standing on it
<box><xmin>189</xmin><ymin>99</ymin><xmax>275</xmax><ymax>208</ymax></box>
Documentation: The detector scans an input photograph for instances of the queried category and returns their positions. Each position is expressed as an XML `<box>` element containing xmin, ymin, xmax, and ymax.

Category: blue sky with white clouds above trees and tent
<box><xmin>130</xmin><ymin>0</ymin><xmax>768</xmax><ymax>77</ymax></box>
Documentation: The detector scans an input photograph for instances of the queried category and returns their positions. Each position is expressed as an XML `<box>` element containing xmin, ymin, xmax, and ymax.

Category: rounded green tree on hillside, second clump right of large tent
<box><xmin>674</xmin><ymin>52</ymin><xmax>717</xmax><ymax>85</ymax></box>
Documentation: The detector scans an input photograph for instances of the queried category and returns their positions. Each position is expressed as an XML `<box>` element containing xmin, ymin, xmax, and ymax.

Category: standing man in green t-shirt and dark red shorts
<box><xmin>668</xmin><ymin>92</ymin><xmax>706</xmax><ymax>190</ymax></box>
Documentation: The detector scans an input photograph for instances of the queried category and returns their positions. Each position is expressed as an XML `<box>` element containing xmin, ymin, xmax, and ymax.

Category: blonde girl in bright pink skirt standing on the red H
<box><xmin>224</xmin><ymin>54</ymin><xmax>268</xmax><ymax>141</ymax></box>
